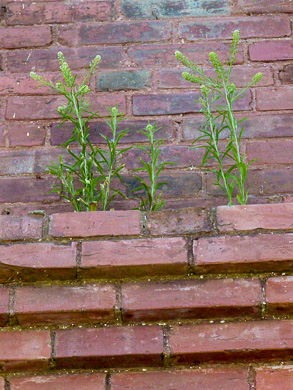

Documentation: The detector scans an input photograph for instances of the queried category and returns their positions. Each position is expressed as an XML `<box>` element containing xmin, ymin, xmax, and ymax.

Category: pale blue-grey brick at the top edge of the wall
<box><xmin>122</xmin><ymin>0</ymin><xmax>231</xmax><ymax>19</ymax></box>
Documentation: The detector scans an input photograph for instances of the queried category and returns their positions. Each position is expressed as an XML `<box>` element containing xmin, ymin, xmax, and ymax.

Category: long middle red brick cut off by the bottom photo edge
<box><xmin>110</xmin><ymin>368</ymin><xmax>249</xmax><ymax>390</ymax></box>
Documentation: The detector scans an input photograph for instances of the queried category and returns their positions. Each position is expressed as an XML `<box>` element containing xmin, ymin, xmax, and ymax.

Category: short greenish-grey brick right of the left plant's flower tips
<box><xmin>96</xmin><ymin>70</ymin><xmax>151</xmax><ymax>91</ymax></box>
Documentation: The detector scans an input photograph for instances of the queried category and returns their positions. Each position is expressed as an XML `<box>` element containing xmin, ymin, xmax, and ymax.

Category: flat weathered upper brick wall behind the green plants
<box><xmin>0</xmin><ymin>0</ymin><xmax>293</xmax><ymax>214</ymax></box>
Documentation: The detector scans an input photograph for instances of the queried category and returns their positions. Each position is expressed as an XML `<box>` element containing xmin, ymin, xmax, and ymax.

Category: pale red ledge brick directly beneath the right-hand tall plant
<box><xmin>217</xmin><ymin>203</ymin><xmax>293</xmax><ymax>233</ymax></box>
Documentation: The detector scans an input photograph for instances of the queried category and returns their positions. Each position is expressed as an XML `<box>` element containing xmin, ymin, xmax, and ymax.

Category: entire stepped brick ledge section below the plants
<box><xmin>0</xmin><ymin>203</ymin><xmax>293</xmax><ymax>390</ymax></box>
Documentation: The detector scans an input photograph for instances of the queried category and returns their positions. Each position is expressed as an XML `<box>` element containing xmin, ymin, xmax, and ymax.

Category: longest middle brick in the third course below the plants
<box><xmin>122</xmin><ymin>279</ymin><xmax>261</xmax><ymax>322</ymax></box>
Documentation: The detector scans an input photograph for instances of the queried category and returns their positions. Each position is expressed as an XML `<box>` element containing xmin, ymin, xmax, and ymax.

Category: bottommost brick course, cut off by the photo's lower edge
<box><xmin>0</xmin><ymin>365</ymin><xmax>293</xmax><ymax>390</ymax></box>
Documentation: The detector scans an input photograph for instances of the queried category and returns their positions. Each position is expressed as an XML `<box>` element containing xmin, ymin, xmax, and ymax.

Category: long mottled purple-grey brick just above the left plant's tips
<box><xmin>58</xmin><ymin>20</ymin><xmax>171</xmax><ymax>46</ymax></box>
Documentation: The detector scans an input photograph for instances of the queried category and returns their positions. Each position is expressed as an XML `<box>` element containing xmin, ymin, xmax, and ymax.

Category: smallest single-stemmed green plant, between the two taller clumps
<box><xmin>133</xmin><ymin>124</ymin><xmax>173</xmax><ymax>211</ymax></box>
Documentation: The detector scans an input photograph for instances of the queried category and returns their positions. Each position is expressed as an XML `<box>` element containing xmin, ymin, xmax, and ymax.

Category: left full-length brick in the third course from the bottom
<box><xmin>14</xmin><ymin>285</ymin><xmax>116</xmax><ymax>325</ymax></box>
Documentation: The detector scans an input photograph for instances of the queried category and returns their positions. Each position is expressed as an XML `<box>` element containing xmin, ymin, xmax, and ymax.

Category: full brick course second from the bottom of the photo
<box><xmin>0</xmin><ymin>320</ymin><xmax>293</xmax><ymax>373</ymax></box>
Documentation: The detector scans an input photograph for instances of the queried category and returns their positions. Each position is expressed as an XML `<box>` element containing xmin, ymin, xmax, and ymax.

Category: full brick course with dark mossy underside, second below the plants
<box><xmin>0</xmin><ymin>233</ymin><xmax>293</xmax><ymax>283</ymax></box>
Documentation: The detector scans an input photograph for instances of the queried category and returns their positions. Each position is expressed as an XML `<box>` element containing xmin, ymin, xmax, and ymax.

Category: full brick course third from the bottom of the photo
<box><xmin>0</xmin><ymin>276</ymin><xmax>293</xmax><ymax>327</ymax></box>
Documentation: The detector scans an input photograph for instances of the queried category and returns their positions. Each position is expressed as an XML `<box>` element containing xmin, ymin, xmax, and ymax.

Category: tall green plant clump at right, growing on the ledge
<box><xmin>175</xmin><ymin>30</ymin><xmax>262</xmax><ymax>205</ymax></box>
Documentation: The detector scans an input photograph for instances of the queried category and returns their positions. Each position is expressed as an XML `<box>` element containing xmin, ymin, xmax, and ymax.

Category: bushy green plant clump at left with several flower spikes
<box><xmin>30</xmin><ymin>52</ymin><xmax>129</xmax><ymax>211</ymax></box>
